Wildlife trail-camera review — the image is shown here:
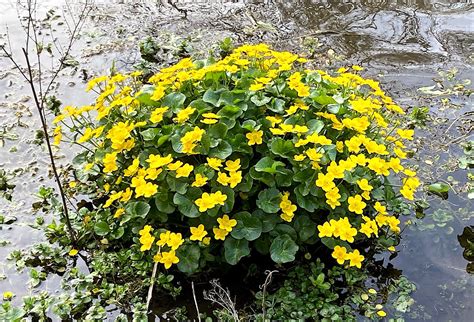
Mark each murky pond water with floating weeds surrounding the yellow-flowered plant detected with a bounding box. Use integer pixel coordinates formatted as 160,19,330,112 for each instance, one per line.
0,0,474,321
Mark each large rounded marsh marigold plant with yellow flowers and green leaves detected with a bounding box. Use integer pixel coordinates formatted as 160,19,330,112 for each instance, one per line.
54,44,420,273
